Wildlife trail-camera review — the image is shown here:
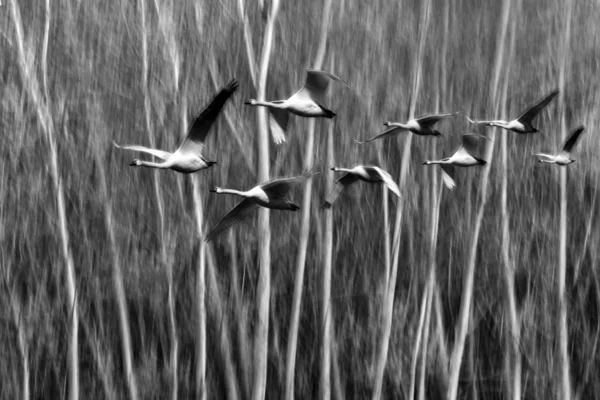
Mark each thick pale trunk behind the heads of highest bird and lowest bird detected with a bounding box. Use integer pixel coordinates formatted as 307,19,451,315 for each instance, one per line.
252,0,279,400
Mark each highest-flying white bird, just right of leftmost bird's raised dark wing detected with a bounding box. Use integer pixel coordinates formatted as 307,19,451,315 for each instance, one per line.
245,69,347,144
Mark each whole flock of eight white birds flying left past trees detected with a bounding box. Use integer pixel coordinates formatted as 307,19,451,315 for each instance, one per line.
113,70,584,241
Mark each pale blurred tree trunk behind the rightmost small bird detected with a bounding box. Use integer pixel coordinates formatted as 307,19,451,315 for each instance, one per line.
558,0,573,400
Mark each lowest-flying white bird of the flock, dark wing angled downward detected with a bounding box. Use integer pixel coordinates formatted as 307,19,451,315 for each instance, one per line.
204,173,314,242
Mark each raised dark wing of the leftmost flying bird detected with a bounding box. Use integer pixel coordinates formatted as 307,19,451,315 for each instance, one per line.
179,79,238,154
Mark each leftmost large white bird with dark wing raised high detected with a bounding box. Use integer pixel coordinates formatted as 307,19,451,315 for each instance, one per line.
113,79,238,174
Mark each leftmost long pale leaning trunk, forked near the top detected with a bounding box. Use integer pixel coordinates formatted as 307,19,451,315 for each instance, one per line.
11,0,79,400
